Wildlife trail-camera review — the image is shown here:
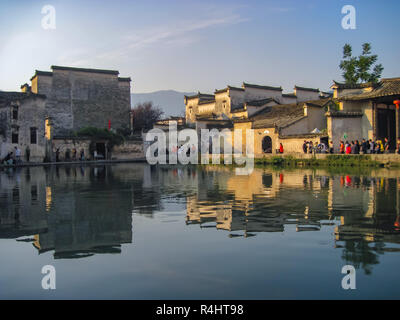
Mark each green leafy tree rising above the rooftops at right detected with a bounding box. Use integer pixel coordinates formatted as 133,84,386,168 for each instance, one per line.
339,43,383,84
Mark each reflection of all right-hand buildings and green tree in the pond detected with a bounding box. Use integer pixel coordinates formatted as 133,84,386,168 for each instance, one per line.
186,167,400,273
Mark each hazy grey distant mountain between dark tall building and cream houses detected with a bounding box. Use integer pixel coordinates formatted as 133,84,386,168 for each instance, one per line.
131,90,195,117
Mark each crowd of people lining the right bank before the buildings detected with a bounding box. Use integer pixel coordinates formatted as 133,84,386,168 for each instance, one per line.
303,138,400,154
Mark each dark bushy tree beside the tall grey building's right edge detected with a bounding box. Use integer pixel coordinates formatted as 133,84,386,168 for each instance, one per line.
132,101,164,132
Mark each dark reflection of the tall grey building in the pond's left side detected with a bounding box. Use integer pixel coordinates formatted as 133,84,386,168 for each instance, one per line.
0,166,134,258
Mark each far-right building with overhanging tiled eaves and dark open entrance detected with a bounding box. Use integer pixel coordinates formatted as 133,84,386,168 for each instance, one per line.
327,78,400,150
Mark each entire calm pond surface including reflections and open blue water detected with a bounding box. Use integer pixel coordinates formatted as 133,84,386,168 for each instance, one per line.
0,164,400,299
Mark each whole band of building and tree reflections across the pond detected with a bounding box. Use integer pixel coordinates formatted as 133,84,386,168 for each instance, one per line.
0,164,400,274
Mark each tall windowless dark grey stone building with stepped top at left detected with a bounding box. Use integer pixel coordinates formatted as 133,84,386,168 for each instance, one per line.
26,66,131,136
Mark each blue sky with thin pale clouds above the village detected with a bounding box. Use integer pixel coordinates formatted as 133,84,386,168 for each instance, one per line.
0,0,400,93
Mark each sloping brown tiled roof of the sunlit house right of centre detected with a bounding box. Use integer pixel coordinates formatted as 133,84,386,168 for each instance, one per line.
250,99,331,128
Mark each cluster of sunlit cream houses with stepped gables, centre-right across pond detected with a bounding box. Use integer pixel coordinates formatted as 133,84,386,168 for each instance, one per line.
185,83,333,157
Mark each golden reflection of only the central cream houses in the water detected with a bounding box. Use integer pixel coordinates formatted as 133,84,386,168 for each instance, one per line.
187,169,329,236
